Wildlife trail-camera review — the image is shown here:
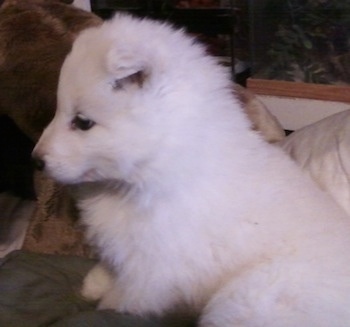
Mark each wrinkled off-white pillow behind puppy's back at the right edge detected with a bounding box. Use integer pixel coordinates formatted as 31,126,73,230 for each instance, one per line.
280,110,350,214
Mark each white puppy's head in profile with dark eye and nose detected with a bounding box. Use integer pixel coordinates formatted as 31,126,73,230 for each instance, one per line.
33,16,234,187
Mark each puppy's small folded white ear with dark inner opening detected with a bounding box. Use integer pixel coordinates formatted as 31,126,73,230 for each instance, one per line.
107,49,149,89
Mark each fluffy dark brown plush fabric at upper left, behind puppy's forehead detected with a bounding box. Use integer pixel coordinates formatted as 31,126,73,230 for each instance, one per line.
0,0,101,140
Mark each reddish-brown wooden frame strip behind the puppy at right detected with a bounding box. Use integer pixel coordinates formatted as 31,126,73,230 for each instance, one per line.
247,78,350,102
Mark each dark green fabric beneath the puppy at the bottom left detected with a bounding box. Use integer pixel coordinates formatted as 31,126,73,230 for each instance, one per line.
0,251,195,327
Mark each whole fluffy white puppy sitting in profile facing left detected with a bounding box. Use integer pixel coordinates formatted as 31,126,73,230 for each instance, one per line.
34,15,350,327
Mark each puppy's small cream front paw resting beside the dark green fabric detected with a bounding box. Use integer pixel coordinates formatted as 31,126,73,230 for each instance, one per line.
81,264,114,301
